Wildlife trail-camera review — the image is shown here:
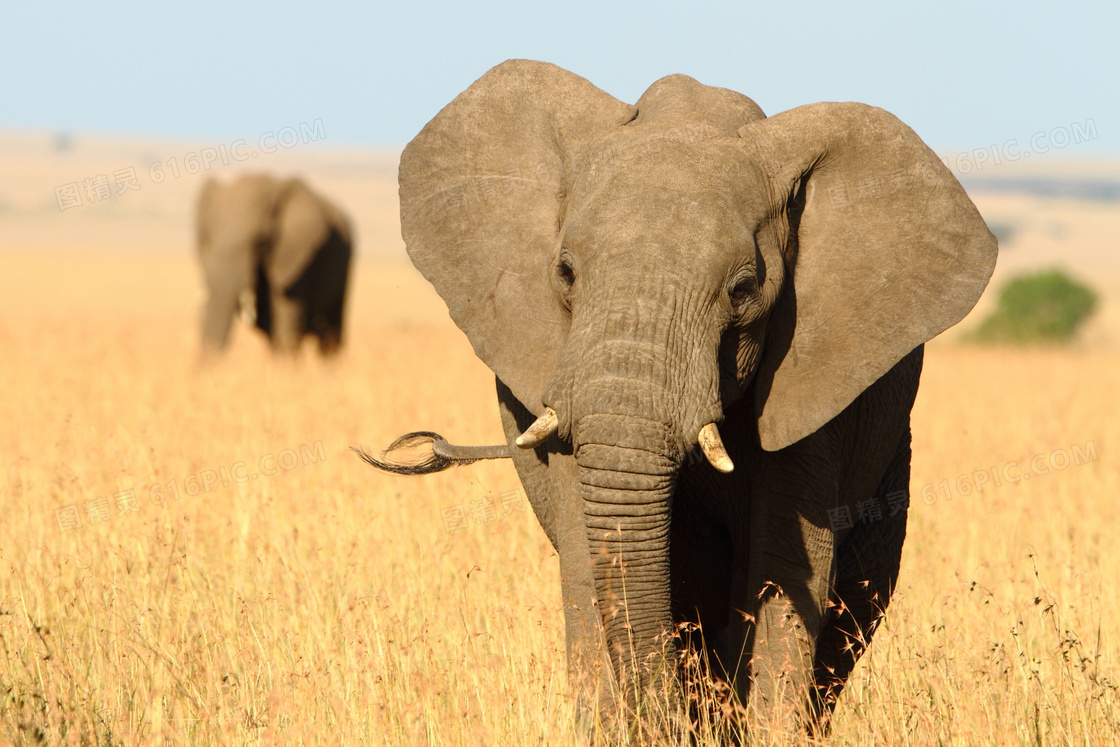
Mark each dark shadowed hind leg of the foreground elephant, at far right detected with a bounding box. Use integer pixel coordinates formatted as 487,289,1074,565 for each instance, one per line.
813,430,911,730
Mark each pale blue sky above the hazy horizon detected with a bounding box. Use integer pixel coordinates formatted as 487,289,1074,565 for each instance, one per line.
0,0,1120,155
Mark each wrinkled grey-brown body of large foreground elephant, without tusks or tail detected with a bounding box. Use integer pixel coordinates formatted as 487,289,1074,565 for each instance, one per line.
400,60,996,734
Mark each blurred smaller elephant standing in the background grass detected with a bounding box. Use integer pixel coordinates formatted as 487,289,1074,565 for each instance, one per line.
197,175,351,355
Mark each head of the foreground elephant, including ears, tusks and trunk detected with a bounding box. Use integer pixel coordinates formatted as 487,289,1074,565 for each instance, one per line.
400,60,996,703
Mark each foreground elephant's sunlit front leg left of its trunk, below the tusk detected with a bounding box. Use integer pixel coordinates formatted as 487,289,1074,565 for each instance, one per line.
497,380,616,717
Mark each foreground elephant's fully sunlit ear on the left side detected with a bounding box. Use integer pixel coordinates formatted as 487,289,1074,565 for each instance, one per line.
400,60,635,413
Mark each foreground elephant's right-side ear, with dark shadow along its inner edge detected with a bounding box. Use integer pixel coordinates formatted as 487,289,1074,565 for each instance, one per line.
739,103,996,451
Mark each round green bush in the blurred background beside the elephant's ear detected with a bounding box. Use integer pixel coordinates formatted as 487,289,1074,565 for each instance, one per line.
968,270,1096,345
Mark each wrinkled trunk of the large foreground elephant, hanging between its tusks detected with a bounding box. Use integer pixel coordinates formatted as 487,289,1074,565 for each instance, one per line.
560,271,719,704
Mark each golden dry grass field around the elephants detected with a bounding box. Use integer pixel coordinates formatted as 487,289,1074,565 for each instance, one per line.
0,252,1120,745
